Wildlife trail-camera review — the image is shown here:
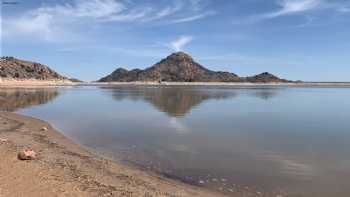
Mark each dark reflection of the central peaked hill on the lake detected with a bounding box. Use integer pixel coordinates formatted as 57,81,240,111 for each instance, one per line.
104,87,238,117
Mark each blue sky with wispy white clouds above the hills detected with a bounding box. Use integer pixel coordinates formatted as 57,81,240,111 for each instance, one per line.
1,0,350,81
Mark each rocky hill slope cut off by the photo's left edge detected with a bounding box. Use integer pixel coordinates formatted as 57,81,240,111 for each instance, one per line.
0,57,68,80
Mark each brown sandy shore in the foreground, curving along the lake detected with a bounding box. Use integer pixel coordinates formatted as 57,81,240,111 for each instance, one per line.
0,112,226,197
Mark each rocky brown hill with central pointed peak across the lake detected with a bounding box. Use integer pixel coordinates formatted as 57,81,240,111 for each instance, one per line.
98,52,287,83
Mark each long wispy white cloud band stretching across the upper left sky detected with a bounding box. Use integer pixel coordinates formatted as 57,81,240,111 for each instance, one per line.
3,0,214,41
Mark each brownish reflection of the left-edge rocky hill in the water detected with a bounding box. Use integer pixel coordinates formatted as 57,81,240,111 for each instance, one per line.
0,88,59,111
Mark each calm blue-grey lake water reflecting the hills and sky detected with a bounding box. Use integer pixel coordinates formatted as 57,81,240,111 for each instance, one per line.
0,86,350,197
